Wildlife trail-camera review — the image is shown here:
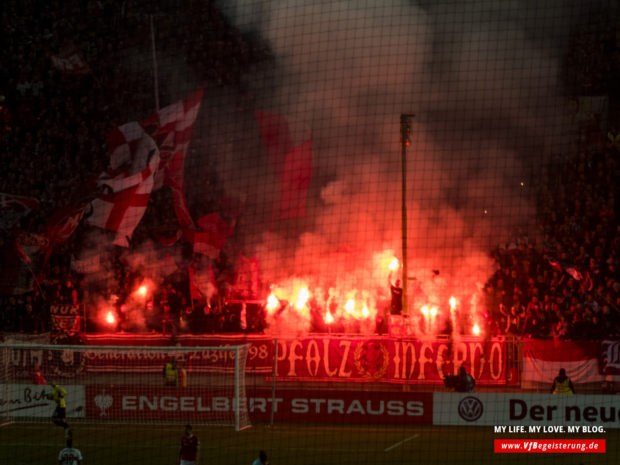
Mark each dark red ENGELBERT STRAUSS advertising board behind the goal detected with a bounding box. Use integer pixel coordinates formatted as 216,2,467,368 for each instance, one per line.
86,385,433,425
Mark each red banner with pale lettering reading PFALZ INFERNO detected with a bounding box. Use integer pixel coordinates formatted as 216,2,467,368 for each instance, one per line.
277,337,506,384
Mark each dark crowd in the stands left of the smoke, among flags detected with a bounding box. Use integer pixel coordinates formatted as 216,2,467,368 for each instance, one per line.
0,0,266,333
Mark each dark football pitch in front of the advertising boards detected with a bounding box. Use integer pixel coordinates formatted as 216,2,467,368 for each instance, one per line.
0,423,620,465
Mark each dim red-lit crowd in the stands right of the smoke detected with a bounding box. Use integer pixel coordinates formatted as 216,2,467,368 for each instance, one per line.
485,148,620,340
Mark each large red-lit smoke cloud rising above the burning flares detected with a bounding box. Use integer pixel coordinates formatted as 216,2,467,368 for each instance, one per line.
208,0,592,334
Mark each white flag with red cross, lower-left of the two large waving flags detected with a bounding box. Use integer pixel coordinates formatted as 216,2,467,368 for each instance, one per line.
87,134,160,247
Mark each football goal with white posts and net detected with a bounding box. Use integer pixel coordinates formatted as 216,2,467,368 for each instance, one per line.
0,344,250,431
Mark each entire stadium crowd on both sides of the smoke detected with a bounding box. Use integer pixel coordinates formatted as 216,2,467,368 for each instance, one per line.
0,0,620,339
